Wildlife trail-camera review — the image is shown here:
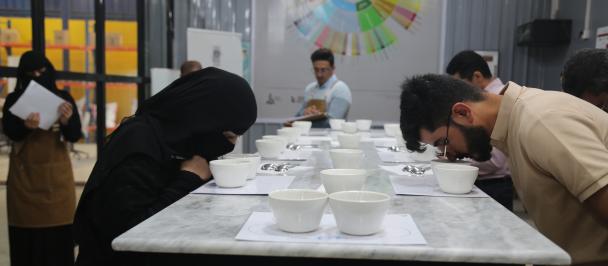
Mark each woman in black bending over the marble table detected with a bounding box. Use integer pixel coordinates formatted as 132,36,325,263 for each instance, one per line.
74,67,257,265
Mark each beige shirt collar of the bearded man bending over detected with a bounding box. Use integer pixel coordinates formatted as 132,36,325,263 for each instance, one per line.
491,81,524,156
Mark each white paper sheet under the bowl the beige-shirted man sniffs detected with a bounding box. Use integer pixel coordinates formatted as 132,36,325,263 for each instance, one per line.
390,173,488,198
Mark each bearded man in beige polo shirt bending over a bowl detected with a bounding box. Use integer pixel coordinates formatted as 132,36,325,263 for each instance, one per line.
400,74,608,265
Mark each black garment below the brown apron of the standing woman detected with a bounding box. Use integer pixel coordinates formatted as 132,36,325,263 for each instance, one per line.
8,225,74,266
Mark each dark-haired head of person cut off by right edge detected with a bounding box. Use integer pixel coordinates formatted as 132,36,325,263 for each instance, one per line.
562,49,608,112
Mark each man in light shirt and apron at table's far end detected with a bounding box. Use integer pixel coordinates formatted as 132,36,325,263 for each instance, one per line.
296,48,352,128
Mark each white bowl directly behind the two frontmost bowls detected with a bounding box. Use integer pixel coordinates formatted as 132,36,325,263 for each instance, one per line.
321,169,367,194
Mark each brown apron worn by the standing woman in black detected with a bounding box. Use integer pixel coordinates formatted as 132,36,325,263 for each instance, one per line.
6,125,76,228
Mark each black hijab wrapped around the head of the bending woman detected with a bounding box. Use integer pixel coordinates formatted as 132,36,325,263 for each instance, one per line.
136,67,257,160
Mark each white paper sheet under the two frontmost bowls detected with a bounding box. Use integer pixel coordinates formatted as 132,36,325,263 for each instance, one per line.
235,212,427,245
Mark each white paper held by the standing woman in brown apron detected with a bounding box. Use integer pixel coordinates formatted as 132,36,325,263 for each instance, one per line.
9,80,65,130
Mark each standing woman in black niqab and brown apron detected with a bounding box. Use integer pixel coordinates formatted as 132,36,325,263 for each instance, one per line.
2,51,82,266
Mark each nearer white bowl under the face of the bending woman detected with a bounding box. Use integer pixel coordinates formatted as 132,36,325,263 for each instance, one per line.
209,159,251,188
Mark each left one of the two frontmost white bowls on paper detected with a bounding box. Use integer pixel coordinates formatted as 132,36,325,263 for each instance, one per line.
268,189,328,233
